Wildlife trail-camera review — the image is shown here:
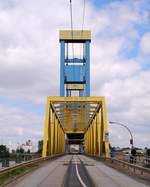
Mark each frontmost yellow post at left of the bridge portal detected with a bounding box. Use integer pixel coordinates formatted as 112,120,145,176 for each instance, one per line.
42,98,50,159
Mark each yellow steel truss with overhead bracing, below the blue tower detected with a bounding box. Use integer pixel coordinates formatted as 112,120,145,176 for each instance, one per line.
42,97,109,158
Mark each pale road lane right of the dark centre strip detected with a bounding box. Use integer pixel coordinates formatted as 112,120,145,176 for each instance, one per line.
80,155,148,187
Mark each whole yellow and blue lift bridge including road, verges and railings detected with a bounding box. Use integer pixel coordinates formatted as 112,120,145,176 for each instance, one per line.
0,30,150,187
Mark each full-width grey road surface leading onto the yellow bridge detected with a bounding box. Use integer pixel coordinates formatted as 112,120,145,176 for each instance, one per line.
7,155,148,187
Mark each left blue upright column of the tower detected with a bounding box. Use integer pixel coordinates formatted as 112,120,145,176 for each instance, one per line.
60,41,65,96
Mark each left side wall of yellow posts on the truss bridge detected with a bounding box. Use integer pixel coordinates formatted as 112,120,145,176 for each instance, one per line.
42,97,65,159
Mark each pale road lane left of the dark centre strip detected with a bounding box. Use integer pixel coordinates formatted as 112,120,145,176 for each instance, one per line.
7,155,71,187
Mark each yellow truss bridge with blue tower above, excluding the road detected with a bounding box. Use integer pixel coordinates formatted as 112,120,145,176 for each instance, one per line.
42,30,109,158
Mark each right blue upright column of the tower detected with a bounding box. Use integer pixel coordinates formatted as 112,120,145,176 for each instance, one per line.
85,41,90,96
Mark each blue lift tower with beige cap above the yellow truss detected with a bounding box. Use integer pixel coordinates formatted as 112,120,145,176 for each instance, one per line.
59,30,91,97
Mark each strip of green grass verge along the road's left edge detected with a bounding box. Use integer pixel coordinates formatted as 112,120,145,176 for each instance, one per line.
0,163,39,186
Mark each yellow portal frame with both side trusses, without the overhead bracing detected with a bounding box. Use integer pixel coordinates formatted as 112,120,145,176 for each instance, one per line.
42,97,110,158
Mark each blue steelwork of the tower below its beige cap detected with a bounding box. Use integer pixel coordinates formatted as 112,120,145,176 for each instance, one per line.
60,40,90,97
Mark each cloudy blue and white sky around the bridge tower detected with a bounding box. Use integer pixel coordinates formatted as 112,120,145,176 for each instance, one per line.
0,0,150,147
